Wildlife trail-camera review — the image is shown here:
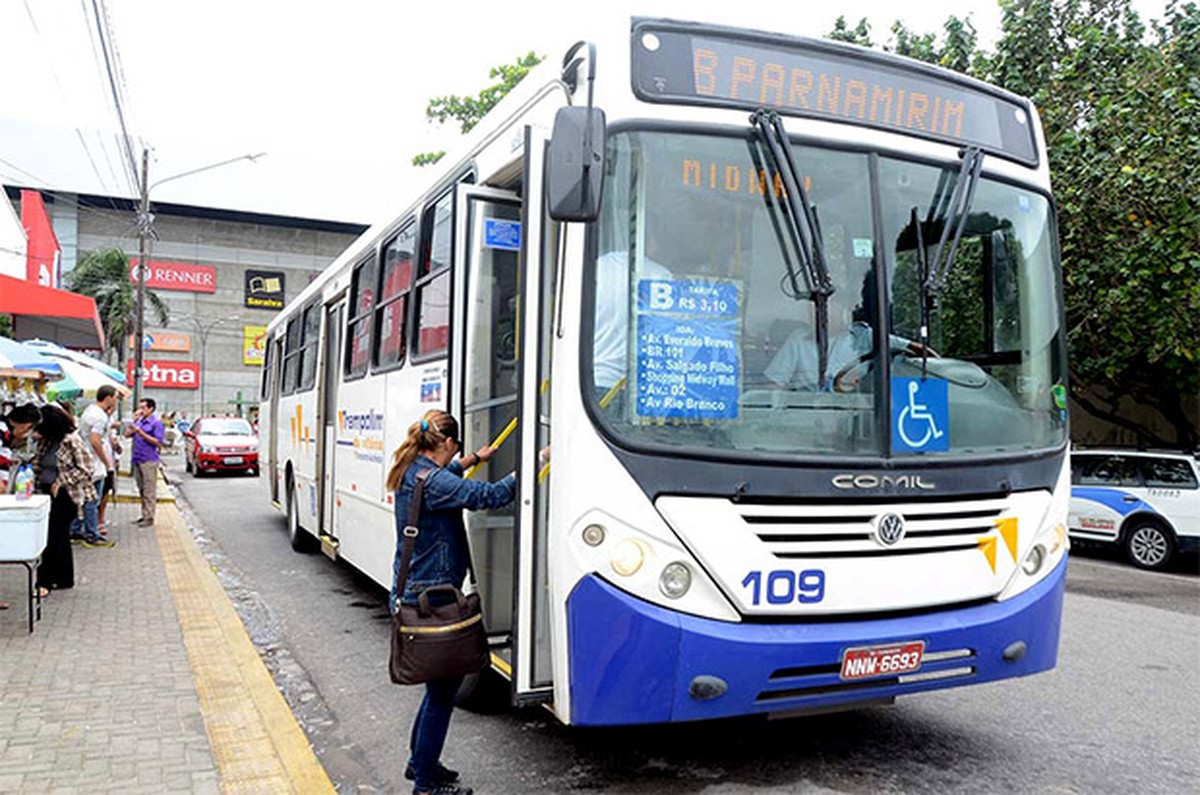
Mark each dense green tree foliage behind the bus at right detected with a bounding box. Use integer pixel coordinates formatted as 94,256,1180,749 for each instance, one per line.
825,0,1200,447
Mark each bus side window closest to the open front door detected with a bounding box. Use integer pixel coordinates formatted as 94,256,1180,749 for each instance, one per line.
413,193,454,359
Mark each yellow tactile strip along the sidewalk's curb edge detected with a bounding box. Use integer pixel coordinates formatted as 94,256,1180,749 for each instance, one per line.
155,506,335,795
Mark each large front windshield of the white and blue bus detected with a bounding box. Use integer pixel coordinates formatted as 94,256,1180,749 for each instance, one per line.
586,131,1066,458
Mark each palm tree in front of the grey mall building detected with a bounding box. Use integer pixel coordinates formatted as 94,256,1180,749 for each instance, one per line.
66,249,170,367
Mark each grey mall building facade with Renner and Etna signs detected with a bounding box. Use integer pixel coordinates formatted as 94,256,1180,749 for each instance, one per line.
10,190,366,418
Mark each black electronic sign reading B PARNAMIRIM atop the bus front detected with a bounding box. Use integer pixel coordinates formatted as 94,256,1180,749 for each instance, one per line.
632,23,1038,166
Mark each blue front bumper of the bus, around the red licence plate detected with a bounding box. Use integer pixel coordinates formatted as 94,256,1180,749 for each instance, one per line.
566,557,1067,725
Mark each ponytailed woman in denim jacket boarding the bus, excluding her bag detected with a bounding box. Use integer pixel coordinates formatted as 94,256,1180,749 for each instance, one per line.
388,410,517,795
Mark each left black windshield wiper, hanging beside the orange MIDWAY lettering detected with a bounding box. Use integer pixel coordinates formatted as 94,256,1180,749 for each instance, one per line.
750,108,834,384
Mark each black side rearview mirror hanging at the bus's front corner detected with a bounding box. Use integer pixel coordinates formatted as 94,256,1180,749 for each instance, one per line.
546,107,605,221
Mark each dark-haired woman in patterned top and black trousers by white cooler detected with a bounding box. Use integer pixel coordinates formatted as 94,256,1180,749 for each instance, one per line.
34,404,96,597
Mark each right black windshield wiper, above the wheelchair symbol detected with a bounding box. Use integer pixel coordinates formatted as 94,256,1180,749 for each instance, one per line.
912,147,983,378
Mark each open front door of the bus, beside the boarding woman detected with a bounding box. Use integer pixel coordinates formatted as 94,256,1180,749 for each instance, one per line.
451,133,552,704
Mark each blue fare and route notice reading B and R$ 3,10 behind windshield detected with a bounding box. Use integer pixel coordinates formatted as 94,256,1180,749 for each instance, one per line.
634,279,742,420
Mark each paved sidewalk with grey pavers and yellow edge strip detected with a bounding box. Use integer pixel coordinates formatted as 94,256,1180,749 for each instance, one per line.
0,477,334,793
